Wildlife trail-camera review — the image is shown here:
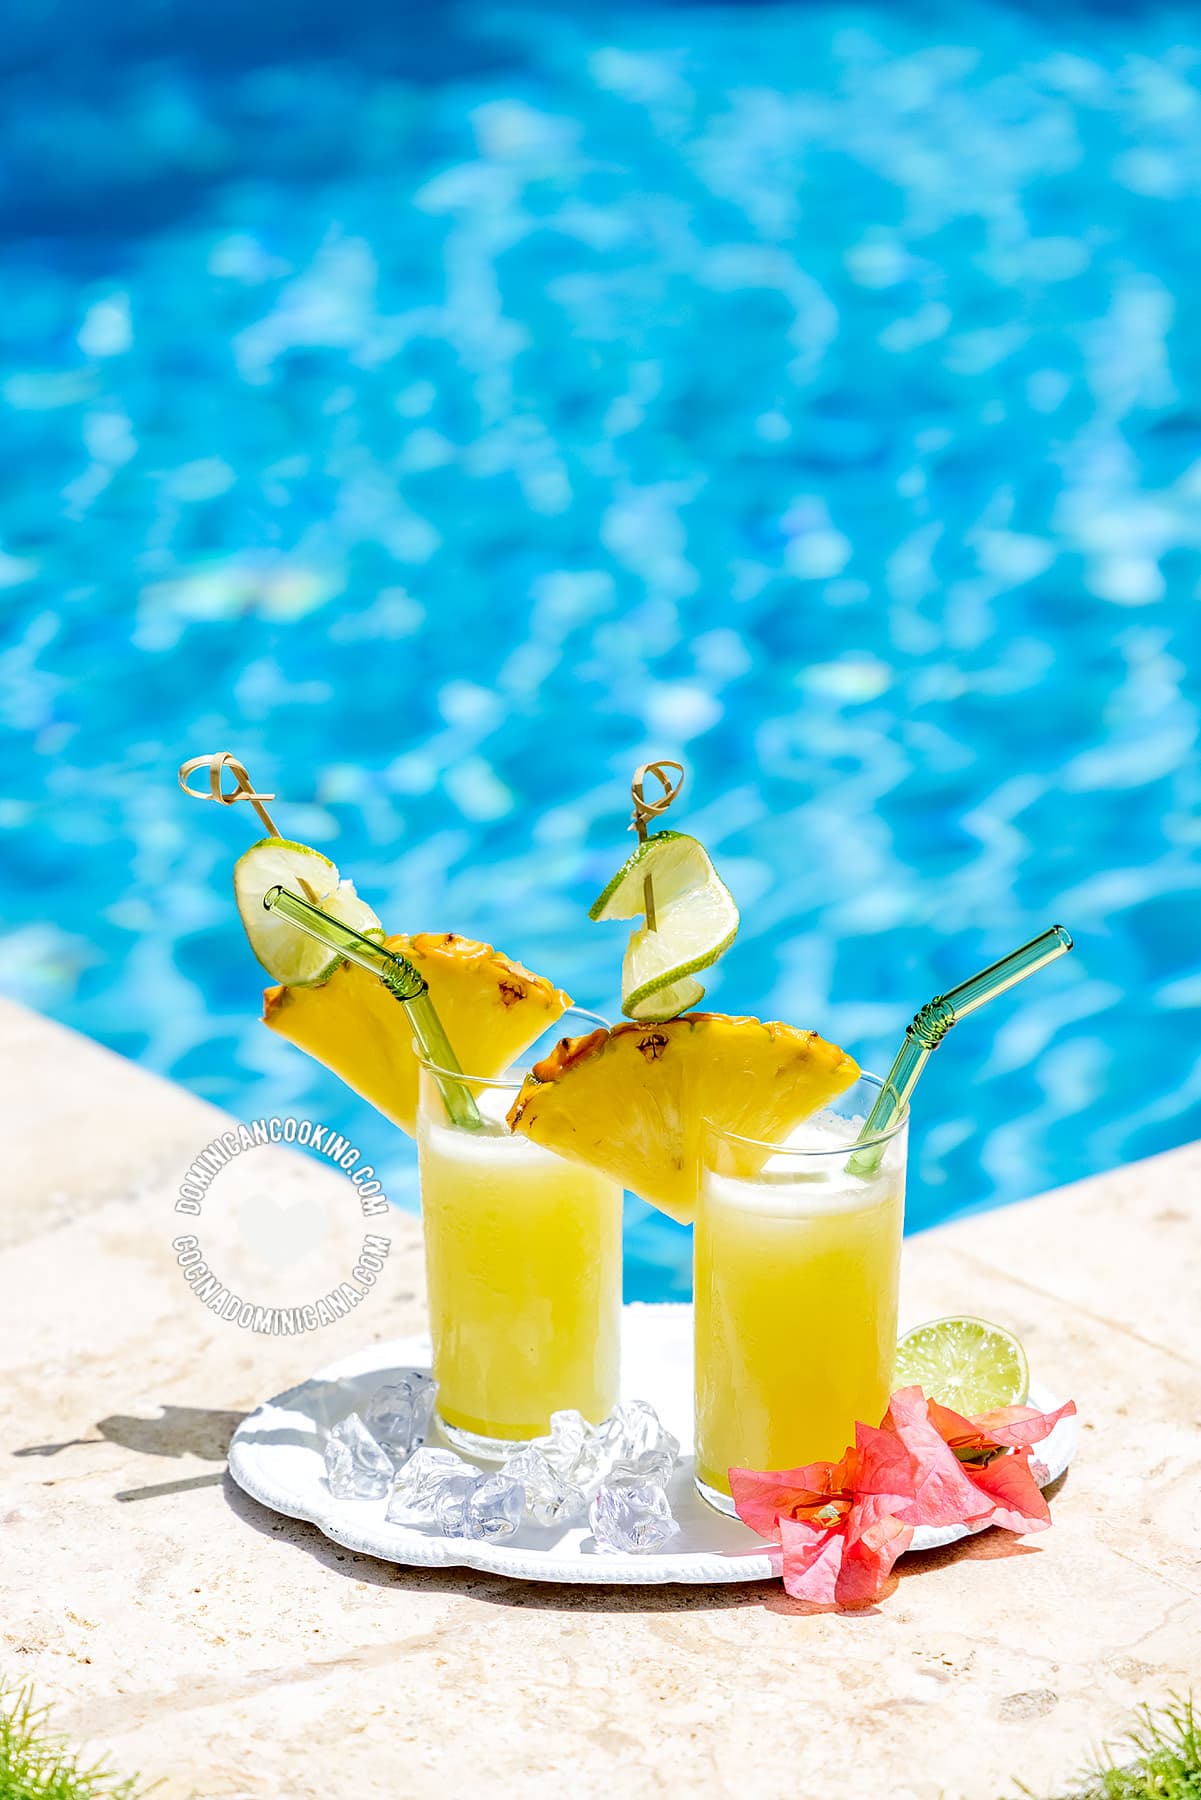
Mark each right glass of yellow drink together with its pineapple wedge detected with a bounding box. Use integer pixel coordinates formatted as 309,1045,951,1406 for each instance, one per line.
508,1012,878,1483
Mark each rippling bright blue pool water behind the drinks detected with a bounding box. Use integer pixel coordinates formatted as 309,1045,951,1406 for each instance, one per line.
0,0,1201,1294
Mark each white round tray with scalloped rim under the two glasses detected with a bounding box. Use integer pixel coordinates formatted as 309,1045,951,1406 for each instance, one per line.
229,1305,1077,1586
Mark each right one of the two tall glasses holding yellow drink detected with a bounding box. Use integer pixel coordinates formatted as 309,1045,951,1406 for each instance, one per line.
693,1075,909,1512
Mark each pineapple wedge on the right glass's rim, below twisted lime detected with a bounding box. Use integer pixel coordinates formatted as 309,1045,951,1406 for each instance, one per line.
508,1013,859,1224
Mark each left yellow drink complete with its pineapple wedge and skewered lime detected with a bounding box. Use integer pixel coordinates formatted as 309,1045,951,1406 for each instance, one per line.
226,828,621,1456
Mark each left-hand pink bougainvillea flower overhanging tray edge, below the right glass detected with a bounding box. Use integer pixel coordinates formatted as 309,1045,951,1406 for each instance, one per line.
729,1424,917,1606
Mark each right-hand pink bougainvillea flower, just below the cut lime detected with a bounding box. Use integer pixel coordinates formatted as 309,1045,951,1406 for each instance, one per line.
884,1388,1075,1532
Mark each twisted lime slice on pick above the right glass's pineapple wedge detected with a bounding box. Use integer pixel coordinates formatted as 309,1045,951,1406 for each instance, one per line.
589,832,738,1019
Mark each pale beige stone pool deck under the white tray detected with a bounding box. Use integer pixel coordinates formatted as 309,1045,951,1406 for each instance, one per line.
0,1003,1201,1800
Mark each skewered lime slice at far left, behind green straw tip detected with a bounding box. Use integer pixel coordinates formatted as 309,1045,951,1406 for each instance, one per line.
234,837,384,988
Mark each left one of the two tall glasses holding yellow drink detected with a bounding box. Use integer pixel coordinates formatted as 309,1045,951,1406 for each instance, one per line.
418,1008,621,1458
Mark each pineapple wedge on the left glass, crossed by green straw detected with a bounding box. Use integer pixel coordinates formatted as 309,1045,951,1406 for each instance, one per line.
263,932,571,1136
